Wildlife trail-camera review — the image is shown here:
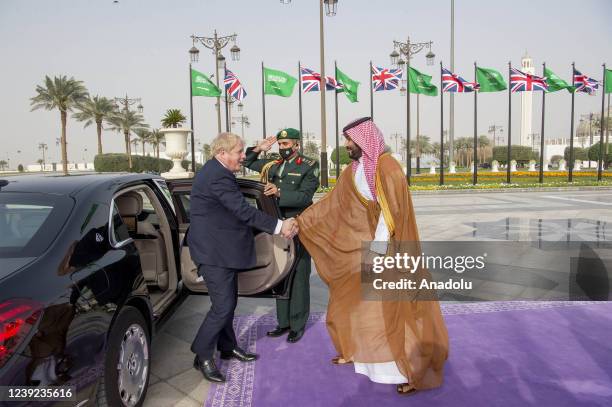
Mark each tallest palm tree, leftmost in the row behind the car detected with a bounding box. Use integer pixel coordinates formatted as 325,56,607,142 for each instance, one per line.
30,75,88,175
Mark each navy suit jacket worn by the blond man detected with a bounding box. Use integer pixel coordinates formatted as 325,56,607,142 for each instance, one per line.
187,158,278,269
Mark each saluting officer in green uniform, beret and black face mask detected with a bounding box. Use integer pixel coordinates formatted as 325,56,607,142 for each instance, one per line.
243,128,319,343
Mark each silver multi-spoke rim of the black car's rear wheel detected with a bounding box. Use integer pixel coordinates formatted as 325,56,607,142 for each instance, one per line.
117,324,149,406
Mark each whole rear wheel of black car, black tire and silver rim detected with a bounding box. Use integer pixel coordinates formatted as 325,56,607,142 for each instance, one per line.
96,306,151,407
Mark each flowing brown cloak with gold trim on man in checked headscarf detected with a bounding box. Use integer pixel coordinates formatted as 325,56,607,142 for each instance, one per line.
298,154,448,389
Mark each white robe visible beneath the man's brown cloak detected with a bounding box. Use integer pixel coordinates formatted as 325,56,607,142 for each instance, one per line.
354,159,408,384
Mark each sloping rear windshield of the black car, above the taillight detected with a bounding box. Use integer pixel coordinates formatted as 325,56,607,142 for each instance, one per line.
0,192,74,258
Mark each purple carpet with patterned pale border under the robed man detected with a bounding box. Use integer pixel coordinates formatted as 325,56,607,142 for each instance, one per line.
206,302,612,407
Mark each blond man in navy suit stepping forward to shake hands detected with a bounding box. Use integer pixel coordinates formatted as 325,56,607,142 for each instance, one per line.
187,133,297,382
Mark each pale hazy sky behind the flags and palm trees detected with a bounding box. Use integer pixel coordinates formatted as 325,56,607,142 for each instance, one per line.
0,0,612,164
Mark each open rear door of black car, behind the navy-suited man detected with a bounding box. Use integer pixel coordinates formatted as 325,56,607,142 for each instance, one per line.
168,178,297,298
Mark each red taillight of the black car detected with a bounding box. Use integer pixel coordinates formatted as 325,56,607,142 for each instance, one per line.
0,299,42,367
